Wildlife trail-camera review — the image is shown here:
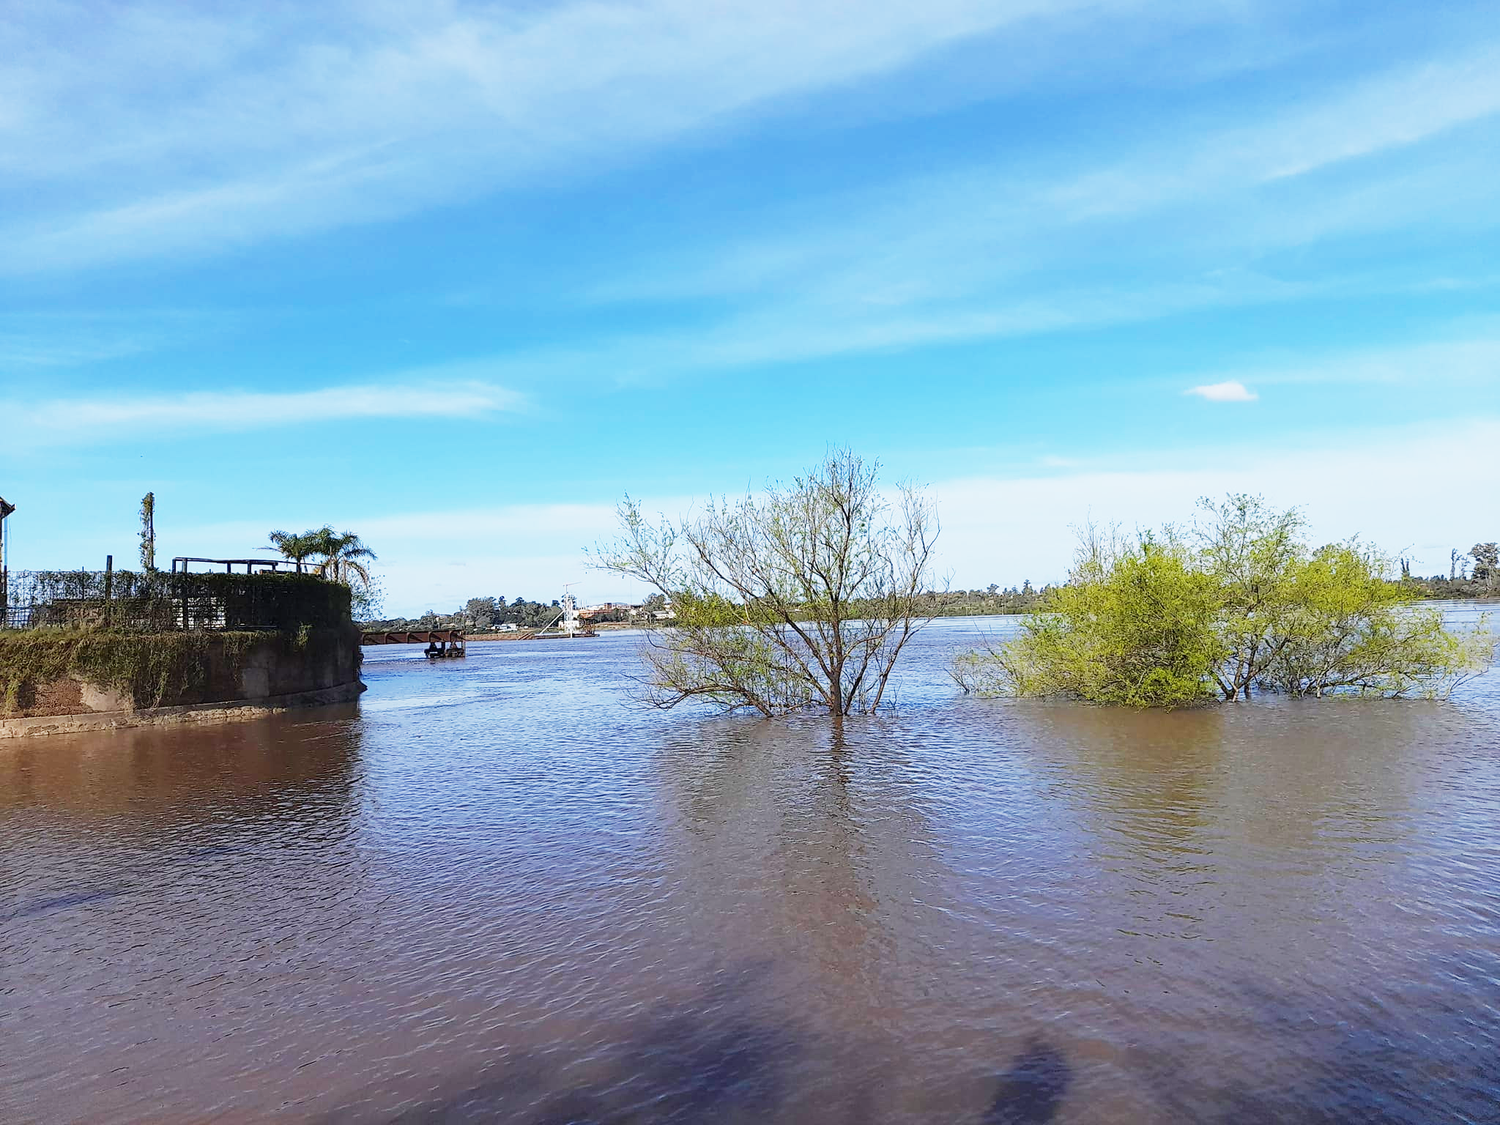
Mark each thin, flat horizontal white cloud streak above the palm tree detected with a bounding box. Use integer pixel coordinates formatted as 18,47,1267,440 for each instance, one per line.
0,383,524,449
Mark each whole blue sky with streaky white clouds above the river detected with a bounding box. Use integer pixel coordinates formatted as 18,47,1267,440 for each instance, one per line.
0,0,1500,614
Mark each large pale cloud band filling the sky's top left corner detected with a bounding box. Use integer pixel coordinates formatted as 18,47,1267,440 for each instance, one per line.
0,0,1136,273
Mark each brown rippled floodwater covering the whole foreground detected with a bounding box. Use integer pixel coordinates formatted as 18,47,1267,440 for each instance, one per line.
0,621,1500,1125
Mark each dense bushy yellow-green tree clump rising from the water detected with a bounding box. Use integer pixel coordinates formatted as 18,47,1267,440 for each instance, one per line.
954,495,1494,707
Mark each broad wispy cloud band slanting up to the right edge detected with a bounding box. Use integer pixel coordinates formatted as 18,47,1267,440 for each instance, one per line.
540,33,1500,386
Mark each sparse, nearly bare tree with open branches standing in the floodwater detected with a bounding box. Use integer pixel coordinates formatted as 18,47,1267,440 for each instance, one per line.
599,450,938,716
